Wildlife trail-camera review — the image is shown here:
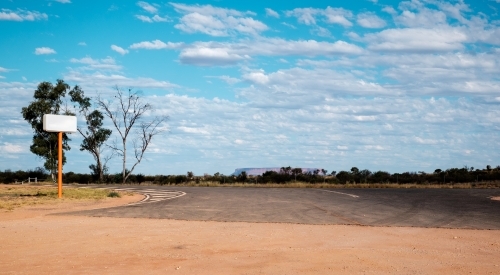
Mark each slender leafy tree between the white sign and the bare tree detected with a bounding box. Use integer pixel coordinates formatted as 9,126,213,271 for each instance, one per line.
69,86,112,182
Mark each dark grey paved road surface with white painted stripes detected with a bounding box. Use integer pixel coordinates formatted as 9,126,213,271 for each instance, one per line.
62,186,500,229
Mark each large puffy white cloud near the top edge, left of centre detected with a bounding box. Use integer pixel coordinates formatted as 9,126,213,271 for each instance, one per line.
170,3,268,36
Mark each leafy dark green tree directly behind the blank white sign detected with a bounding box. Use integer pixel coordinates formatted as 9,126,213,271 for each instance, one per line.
21,79,71,182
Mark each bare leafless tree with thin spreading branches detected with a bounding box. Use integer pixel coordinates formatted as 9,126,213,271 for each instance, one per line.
97,87,168,183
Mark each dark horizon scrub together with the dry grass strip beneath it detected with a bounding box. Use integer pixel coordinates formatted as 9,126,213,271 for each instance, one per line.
0,165,500,188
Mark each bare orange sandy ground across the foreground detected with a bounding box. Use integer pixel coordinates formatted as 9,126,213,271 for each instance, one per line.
0,195,500,274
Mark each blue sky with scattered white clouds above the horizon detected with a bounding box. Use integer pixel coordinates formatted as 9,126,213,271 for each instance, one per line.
0,0,500,175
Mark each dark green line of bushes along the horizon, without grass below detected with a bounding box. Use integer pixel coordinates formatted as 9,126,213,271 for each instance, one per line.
0,165,500,185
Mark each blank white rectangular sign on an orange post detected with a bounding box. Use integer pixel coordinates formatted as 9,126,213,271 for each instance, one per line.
43,114,76,198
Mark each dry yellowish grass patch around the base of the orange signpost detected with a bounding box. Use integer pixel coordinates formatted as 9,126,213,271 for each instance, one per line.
0,185,127,210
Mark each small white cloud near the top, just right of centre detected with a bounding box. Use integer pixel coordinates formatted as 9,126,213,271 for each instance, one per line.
286,7,352,27
